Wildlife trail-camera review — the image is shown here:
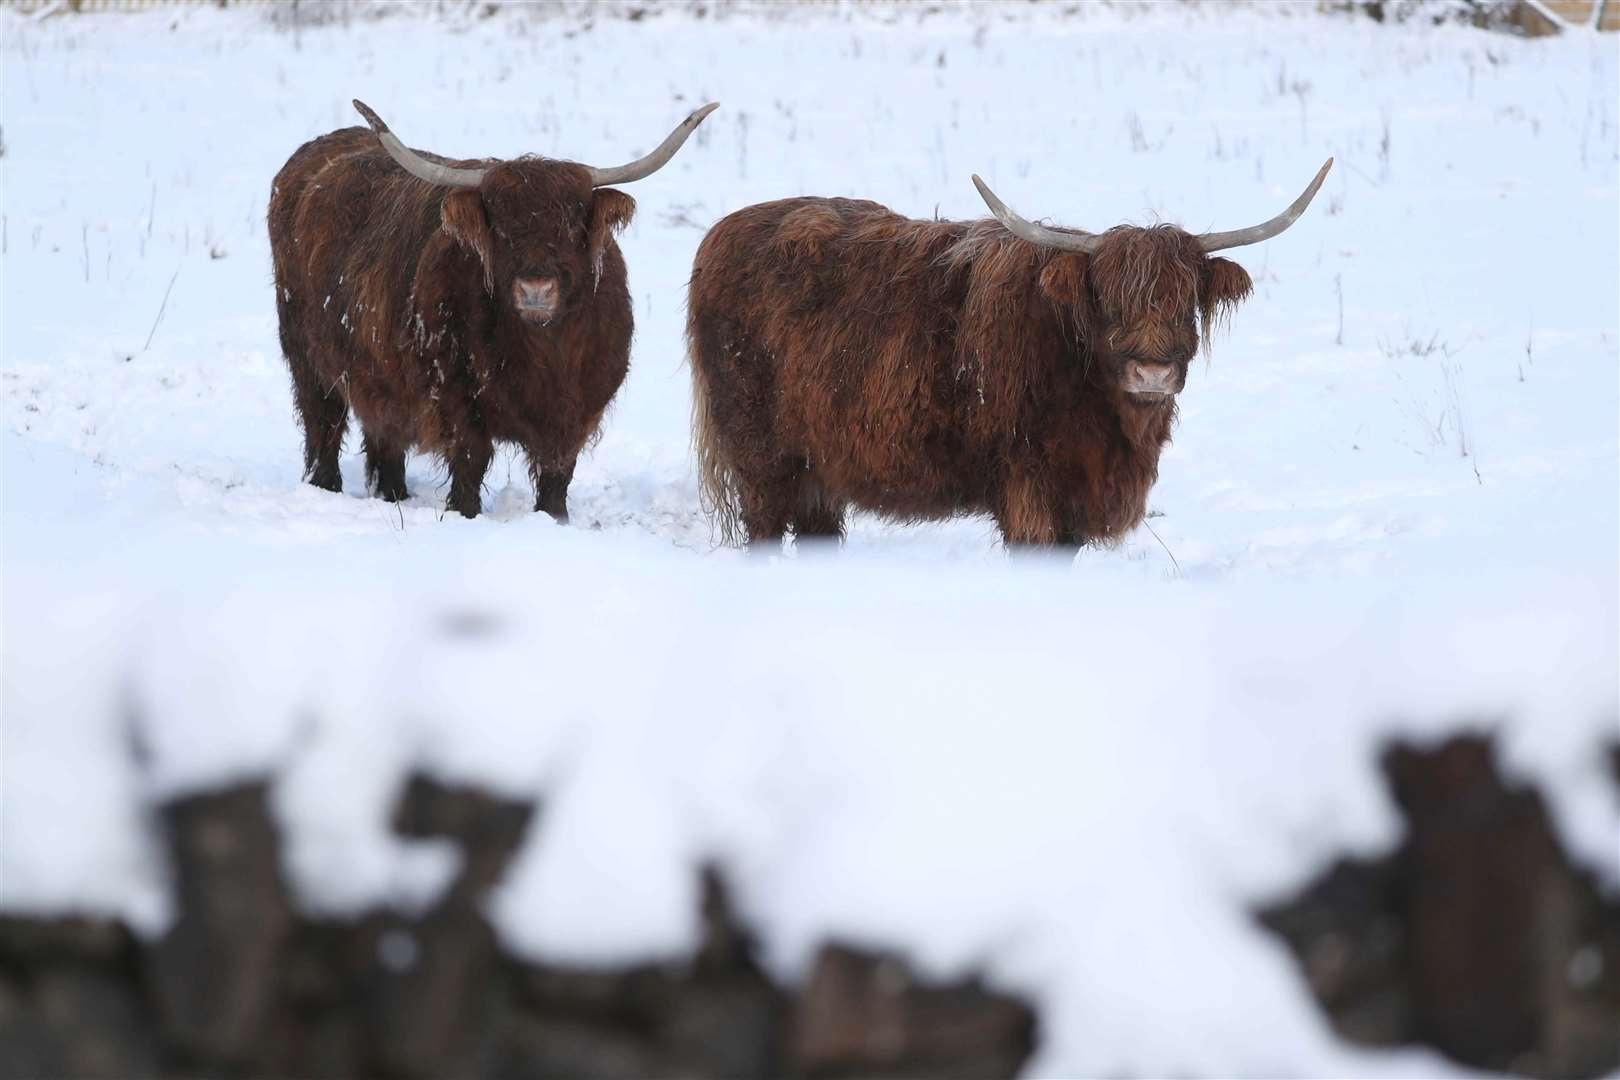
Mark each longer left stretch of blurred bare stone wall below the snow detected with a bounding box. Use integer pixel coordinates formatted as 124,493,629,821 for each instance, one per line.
0,777,1035,1080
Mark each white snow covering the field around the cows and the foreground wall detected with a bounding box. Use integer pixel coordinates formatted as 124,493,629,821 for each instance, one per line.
0,5,1620,1075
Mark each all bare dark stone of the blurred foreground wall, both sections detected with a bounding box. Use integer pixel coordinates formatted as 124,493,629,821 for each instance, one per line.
0,735,1620,1080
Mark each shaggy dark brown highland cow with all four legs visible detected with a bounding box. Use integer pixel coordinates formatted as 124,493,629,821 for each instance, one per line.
269,102,716,521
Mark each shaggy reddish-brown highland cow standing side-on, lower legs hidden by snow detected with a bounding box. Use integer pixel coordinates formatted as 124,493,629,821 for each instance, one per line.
687,159,1333,546
